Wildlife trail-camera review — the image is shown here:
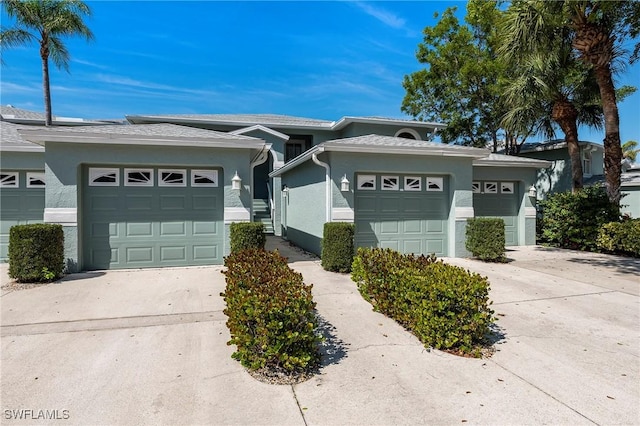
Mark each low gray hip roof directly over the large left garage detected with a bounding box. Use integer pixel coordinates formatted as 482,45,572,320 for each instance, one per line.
19,124,264,148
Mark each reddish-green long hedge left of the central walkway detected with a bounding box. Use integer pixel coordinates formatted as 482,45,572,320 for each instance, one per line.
221,249,320,373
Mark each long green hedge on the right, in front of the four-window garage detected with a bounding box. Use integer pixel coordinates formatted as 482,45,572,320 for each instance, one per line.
351,248,495,356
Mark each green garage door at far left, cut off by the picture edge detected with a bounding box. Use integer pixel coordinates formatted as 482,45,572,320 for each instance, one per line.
0,170,44,261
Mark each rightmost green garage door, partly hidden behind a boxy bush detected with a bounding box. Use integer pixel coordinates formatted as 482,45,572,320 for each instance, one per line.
473,181,520,246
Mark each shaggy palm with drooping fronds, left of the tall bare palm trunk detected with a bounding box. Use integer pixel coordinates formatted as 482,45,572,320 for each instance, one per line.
499,2,602,191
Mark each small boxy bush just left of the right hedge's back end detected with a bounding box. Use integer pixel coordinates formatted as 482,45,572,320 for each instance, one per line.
322,222,355,272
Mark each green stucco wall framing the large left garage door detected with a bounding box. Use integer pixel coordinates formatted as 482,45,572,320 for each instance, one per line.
45,142,251,272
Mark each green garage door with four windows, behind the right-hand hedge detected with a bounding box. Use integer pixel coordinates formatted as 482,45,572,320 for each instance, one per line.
355,174,450,256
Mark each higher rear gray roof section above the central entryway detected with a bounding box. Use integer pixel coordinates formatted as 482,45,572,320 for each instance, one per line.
127,114,333,128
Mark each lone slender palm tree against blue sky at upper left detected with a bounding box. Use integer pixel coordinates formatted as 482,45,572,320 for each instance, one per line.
0,0,93,126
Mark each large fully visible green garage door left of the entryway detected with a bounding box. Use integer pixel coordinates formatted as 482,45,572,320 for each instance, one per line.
82,166,224,269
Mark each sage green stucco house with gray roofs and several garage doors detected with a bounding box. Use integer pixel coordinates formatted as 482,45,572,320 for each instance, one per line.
2,110,550,271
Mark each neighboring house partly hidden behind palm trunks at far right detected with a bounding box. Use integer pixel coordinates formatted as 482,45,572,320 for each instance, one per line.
519,140,640,218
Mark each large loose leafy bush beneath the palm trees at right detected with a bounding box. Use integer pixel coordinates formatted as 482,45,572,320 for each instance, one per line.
540,186,620,251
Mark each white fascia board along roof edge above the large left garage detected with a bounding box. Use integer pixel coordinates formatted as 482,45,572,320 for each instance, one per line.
18,130,265,149
